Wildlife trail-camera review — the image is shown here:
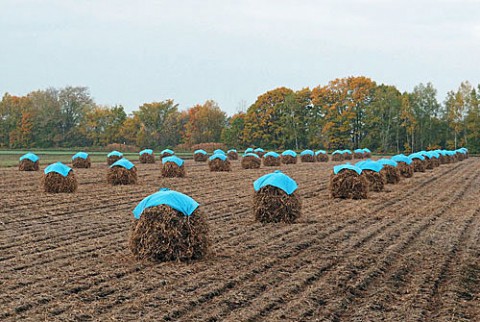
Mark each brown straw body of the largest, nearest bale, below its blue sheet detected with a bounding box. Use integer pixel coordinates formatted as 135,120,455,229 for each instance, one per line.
128,205,210,262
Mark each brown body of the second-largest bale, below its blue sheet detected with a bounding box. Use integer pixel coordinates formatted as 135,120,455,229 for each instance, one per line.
253,186,302,224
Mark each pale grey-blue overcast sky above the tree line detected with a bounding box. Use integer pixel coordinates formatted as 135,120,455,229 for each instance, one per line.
0,0,480,115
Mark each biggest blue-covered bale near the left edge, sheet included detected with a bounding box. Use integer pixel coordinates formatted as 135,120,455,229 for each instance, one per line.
42,162,78,193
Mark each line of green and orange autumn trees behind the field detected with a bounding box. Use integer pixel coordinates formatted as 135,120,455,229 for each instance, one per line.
0,76,480,152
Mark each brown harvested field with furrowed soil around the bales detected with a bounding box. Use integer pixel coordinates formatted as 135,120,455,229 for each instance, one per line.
0,158,480,321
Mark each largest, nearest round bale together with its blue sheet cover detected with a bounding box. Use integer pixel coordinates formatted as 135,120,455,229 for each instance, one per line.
129,190,210,262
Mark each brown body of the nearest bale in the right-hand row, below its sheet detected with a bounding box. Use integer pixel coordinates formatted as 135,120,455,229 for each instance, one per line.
329,169,368,199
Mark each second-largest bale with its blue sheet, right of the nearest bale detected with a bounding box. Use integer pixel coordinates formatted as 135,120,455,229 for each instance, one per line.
253,170,302,224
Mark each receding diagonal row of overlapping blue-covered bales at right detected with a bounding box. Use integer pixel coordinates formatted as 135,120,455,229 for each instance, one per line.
329,148,468,199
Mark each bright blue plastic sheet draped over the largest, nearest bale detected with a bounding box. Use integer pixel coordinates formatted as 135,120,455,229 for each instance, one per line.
133,188,199,219
